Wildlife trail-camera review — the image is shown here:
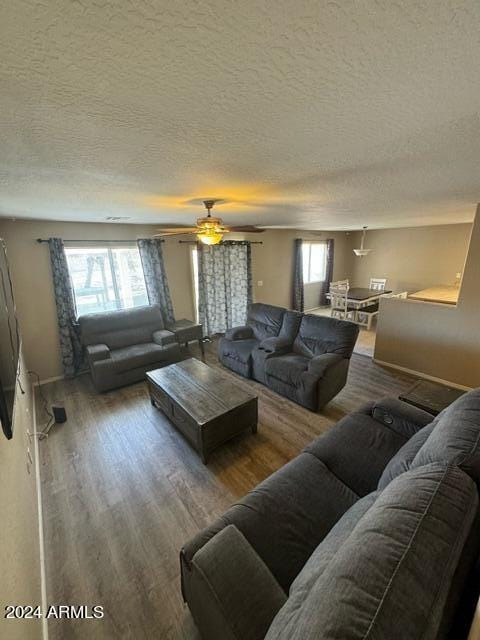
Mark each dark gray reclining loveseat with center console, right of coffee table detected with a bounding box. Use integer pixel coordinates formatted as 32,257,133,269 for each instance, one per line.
218,303,359,411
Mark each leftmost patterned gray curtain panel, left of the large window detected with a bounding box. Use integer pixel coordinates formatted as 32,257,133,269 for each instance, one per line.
48,238,85,378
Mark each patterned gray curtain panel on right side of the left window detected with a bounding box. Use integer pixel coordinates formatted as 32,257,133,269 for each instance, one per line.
137,238,175,325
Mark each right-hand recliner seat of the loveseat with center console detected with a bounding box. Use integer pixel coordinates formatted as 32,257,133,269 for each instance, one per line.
265,315,359,411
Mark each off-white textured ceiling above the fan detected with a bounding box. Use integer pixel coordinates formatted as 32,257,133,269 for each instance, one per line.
0,0,480,229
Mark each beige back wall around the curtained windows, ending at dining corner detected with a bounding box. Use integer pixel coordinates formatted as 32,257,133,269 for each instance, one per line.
0,220,350,380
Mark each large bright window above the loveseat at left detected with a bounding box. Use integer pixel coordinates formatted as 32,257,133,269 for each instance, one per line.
65,246,148,317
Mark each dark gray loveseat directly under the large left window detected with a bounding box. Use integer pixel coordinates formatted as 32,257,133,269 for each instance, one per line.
78,304,184,391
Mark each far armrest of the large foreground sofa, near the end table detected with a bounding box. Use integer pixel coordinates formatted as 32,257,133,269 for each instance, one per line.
372,397,434,438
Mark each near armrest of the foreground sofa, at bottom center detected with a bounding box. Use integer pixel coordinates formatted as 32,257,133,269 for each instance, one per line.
182,525,287,640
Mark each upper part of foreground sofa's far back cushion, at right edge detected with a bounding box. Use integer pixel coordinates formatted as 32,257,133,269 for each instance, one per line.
411,388,480,484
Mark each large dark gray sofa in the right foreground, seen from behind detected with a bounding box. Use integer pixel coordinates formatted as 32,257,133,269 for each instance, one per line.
180,389,480,640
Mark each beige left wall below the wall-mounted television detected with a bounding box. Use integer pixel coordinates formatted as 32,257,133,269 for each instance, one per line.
0,352,42,640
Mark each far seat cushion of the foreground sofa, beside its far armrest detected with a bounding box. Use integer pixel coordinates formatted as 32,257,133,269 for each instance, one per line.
305,406,406,496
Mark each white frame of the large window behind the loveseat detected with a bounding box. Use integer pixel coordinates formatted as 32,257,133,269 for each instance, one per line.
65,240,149,320
